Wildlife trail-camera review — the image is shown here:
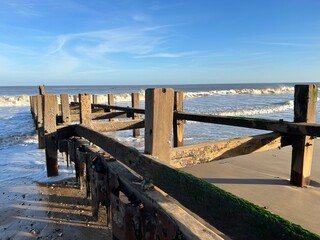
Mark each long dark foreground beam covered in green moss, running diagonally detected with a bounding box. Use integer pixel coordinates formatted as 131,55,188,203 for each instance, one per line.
67,125,317,239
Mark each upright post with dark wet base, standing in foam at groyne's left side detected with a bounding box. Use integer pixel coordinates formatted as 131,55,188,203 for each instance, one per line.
43,94,59,177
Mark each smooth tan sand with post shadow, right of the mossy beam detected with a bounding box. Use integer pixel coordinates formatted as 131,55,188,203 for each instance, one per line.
182,140,320,234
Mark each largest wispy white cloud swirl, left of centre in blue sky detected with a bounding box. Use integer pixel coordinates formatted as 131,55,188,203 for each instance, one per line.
49,26,171,58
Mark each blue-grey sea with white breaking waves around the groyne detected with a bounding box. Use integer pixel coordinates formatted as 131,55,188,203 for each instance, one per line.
0,83,320,184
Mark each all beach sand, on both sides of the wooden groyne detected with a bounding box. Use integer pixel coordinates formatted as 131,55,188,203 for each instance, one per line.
0,141,320,240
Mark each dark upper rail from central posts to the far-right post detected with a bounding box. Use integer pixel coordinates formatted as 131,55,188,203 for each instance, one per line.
174,112,320,137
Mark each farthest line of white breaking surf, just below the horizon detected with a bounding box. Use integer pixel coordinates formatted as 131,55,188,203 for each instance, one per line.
0,87,294,107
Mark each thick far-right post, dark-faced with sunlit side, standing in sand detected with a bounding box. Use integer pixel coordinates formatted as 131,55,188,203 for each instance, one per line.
290,85,318,187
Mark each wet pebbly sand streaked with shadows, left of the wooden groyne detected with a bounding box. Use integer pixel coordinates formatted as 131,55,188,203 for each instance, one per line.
0,179,112,240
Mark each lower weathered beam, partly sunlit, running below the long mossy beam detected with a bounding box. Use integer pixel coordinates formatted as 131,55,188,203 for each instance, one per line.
72,138,223,240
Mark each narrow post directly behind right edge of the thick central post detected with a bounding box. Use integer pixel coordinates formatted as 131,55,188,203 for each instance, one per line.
173,92,184,147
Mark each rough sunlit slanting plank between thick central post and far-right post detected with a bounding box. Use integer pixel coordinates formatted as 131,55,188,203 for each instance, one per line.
170,133,289,168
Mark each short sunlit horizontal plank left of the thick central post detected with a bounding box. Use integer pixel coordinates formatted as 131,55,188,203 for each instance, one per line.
91,119,144,132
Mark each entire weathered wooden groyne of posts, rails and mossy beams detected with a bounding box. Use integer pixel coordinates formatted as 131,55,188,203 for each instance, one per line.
30,85,320,239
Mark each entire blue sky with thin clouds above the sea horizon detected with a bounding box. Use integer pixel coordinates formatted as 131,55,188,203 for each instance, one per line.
0,0,320,85
